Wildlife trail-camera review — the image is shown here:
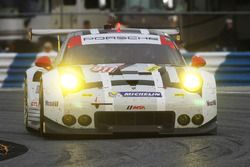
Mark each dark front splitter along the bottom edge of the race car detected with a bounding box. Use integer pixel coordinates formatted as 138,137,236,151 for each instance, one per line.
44,117,217,135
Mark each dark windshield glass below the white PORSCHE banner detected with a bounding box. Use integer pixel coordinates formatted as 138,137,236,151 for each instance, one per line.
61,44,185,66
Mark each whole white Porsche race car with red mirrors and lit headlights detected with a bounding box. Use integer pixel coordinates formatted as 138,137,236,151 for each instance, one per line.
24,28,217,135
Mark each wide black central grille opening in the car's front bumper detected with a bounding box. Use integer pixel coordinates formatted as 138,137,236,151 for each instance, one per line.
94,111,175,129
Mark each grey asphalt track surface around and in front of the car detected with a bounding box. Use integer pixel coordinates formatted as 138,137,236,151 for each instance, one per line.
0,91,250,167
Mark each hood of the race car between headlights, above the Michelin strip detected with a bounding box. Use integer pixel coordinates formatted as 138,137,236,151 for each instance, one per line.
72,63,184,88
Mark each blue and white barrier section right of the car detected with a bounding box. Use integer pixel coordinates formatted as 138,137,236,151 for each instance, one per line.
184,52,250,86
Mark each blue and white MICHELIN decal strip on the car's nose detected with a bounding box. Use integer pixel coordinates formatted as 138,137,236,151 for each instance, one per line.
109,92,162,97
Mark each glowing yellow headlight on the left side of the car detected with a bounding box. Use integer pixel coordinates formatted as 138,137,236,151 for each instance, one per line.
61,73,78,90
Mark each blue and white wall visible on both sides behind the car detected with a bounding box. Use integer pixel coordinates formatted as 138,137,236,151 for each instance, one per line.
0,52,250,88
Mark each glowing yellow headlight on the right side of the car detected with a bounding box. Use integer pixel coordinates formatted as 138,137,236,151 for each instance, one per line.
182,73,202,92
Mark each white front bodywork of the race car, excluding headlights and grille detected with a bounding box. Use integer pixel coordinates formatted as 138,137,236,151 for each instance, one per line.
43,64,217,129
